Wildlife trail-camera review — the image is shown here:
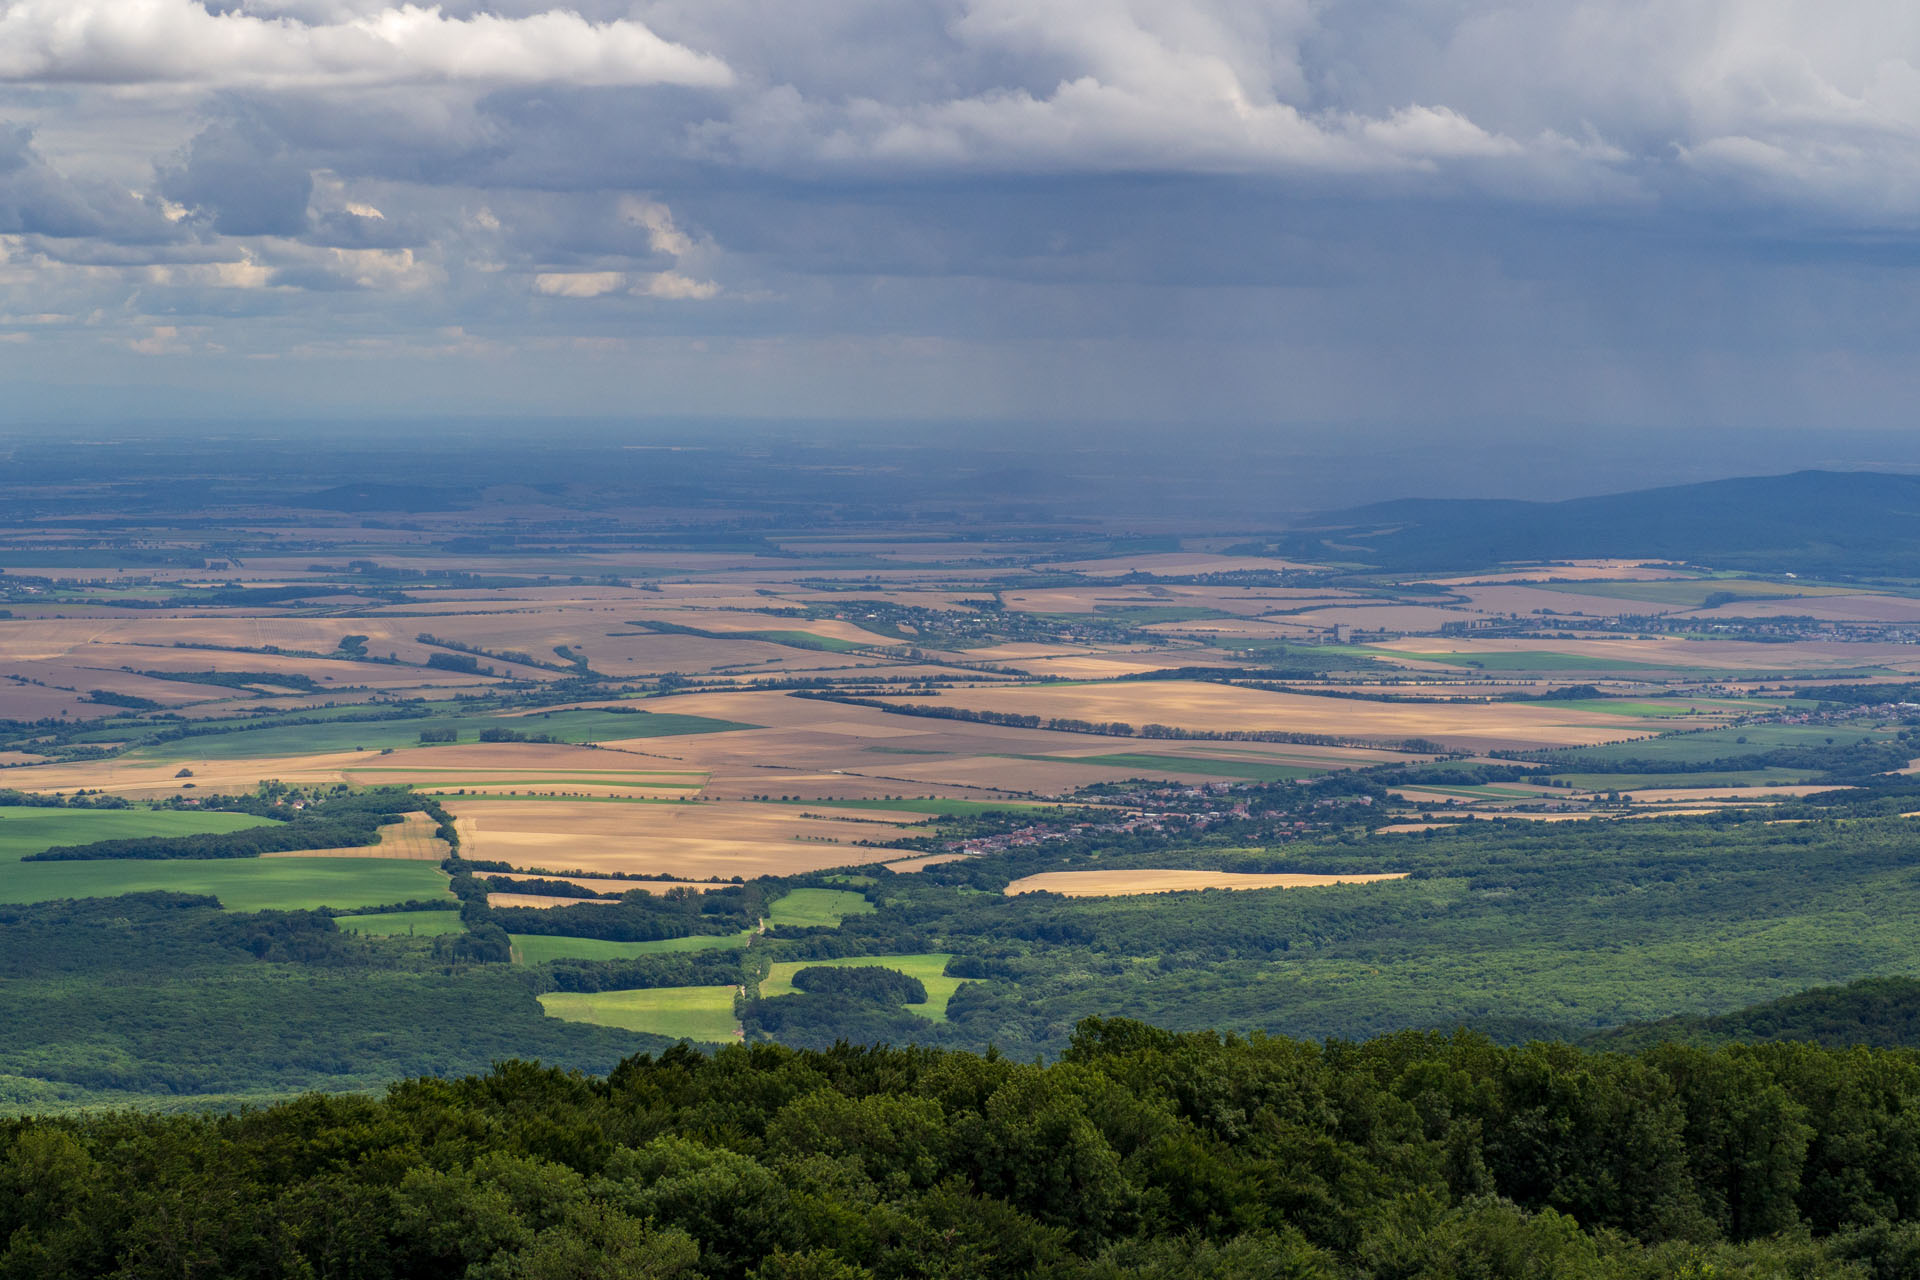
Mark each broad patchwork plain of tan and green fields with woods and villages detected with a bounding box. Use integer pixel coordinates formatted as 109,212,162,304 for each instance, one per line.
11,443,1920,1105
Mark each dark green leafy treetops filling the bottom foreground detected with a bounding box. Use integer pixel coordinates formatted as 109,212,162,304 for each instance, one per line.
11,1021,1920,1280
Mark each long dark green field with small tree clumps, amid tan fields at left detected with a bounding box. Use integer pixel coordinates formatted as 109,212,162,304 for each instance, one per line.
129,710,756,762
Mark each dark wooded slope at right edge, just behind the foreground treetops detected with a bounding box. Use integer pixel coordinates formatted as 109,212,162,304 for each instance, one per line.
1586,977,1920,1050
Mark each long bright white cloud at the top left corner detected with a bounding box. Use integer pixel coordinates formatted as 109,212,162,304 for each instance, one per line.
0,0,733,88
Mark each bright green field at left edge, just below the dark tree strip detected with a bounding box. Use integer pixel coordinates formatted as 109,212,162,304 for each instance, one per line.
0,858,453,912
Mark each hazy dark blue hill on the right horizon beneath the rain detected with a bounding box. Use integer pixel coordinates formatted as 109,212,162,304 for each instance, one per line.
1283,470,1920,574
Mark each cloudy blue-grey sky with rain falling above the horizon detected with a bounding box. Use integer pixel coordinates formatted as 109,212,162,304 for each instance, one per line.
0,0,1920,441
